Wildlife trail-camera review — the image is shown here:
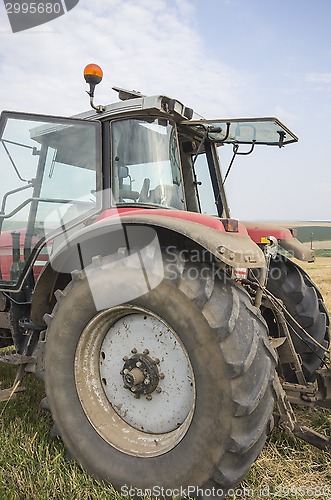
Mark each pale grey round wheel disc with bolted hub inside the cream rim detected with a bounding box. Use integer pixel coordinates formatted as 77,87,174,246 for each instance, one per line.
99,310,194,433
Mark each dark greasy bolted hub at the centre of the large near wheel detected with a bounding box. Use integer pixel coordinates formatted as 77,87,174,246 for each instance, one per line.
120,349,160,397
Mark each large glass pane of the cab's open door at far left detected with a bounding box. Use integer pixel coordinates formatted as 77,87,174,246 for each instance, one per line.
0,113,101,286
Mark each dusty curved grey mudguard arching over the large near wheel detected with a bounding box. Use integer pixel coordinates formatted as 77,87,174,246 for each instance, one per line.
31,211,266,325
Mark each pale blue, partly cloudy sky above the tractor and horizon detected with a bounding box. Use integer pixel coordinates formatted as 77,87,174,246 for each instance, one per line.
0,0,331,221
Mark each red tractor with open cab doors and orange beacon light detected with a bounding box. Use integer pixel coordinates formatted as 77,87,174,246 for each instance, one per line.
0,64,331,498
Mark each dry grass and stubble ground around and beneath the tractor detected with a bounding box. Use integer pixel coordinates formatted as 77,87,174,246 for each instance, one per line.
0,258,331,500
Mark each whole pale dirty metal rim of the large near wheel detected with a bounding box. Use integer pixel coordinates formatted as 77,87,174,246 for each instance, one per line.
75,306,195,456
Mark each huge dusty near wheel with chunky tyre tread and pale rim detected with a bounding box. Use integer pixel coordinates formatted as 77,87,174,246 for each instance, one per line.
45,256,275,498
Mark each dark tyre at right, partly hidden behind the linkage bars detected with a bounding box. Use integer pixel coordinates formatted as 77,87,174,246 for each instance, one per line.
265,255,330,383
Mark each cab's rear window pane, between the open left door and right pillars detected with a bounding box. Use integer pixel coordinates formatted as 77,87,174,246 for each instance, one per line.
111,119,185,210
